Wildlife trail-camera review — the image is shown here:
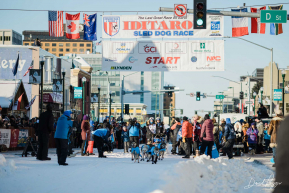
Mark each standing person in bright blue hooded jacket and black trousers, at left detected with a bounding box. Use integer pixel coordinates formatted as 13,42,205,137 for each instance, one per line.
54,110,73,166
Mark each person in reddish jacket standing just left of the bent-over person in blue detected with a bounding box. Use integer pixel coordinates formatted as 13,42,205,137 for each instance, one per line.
81,115,90,156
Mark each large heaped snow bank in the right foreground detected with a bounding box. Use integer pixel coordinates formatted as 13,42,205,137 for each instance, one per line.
153,155,272,193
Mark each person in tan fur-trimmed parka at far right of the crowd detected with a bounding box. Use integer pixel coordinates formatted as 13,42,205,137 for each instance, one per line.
268,110,283,167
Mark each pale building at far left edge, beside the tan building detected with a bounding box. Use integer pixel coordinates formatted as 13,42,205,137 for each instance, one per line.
0,29,22,45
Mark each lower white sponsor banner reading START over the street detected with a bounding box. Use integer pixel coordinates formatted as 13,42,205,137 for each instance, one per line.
102,40,224,71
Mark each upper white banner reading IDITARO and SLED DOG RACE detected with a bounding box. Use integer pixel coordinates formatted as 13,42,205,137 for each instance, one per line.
102,15,224,38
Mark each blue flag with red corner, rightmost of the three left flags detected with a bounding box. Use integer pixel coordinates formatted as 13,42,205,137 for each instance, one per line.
83,13,97,41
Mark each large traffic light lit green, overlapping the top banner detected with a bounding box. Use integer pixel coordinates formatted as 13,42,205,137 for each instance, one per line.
194,0,207,29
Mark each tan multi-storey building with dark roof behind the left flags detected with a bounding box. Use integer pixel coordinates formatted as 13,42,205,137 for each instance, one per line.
22,28,93,57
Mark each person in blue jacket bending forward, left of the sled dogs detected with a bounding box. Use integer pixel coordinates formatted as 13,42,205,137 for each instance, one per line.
91,123,112,158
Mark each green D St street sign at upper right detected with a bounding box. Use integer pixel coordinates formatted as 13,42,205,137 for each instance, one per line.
260,10,287,23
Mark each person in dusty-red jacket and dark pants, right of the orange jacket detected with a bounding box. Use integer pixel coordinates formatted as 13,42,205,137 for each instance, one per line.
200,114,214,158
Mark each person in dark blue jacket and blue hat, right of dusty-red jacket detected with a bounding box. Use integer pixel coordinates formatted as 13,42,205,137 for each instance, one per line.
222,118,235,159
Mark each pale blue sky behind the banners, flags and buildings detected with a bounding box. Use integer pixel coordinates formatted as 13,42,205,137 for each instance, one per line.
0,0,289,116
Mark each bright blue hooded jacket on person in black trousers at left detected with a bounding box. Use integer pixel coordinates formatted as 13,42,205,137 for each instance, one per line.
54,114,73,139
